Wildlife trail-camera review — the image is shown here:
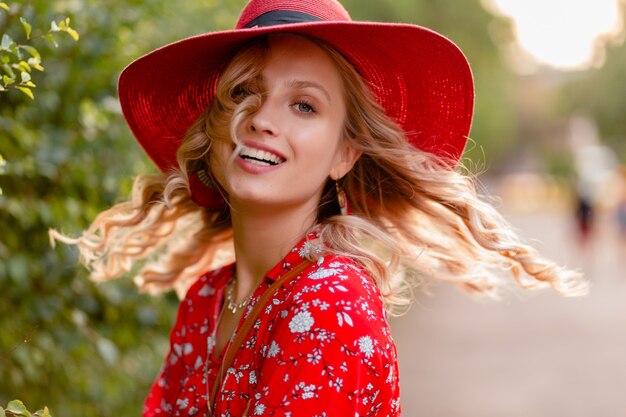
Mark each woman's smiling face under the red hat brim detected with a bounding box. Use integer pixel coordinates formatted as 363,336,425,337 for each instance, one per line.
211,35,358,213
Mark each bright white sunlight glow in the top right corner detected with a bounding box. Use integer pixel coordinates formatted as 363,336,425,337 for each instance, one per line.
484,0,623,70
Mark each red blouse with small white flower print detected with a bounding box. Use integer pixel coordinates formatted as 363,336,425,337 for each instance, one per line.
143,235,400,417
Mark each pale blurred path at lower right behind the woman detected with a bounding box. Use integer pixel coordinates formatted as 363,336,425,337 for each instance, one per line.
391,210,626,417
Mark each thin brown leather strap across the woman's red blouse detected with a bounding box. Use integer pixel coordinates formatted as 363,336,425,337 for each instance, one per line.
209,260,312,410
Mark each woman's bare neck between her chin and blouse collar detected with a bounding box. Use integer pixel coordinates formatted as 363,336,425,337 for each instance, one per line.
231,203,316,300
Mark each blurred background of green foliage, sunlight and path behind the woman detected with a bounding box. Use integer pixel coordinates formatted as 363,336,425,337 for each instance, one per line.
0,0,626,417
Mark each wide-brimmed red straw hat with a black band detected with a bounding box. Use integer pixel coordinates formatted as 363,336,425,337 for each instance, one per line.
119,0,474,177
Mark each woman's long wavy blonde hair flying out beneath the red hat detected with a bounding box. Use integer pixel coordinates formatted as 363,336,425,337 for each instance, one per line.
51,37,587,308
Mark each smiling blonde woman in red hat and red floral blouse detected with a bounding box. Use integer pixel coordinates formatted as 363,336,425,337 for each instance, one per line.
52,0,584,416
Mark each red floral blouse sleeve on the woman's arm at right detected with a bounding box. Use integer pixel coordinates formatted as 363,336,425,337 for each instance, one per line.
249,262,400,417
